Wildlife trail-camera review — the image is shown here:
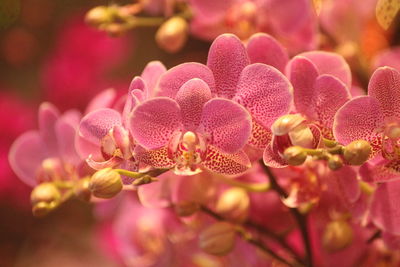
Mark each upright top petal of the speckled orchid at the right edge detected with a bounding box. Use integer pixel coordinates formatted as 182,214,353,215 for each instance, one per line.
368,67,400,118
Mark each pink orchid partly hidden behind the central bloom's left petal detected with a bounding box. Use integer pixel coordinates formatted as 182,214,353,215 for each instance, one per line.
76,61,165,175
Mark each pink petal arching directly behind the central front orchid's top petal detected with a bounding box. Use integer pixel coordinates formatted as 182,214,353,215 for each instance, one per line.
156,62,215,98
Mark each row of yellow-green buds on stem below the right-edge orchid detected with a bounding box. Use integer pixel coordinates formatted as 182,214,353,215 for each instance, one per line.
284,140,372,170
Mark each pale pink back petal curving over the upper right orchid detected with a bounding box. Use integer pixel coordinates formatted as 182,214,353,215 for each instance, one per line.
300,51,351,88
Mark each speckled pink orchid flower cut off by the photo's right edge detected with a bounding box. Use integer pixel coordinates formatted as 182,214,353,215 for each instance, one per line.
334,67,400,182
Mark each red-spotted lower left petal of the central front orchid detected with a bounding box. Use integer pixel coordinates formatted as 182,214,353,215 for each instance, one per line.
135,146,175,169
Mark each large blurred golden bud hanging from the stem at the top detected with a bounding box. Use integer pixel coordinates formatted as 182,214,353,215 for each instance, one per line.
156,17,189,53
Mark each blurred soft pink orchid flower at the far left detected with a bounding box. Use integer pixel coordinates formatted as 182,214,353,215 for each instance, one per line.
9,103,83,187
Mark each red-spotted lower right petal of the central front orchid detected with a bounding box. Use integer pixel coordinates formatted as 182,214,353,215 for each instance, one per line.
202,146,251,175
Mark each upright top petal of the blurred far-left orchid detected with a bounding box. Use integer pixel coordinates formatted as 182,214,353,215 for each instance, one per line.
39,102,60,156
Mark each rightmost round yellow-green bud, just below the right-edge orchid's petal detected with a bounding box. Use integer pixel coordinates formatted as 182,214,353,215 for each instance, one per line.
343,140,372,165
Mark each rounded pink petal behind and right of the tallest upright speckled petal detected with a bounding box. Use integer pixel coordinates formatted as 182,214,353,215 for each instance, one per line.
246,33,289,72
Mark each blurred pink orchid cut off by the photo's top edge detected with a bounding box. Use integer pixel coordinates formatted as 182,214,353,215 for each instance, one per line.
189,0,317,52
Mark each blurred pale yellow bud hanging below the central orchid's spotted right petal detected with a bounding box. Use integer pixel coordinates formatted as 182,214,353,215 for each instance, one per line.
216,187,250,222
